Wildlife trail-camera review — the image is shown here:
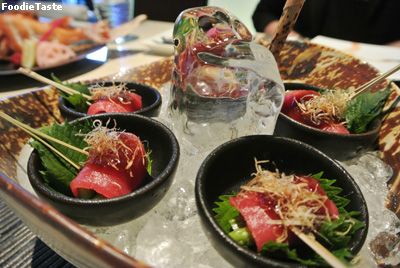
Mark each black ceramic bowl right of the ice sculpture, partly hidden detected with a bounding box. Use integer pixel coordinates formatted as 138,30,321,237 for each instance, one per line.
274,83,381,160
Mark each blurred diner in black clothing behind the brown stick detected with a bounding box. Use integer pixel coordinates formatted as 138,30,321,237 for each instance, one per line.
252,0,400,46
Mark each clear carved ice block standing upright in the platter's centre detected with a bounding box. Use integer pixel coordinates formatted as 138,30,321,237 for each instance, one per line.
169,7,284,152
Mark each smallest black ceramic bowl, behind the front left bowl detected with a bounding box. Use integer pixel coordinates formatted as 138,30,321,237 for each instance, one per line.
58,82,161,120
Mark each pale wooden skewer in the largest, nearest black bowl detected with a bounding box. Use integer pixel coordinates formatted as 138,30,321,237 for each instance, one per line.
291,227,346,268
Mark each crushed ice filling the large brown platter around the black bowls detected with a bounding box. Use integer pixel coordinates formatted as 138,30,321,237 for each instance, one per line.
85,90,400,268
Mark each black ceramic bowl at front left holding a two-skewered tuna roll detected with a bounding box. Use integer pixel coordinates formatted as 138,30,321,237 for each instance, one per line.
28,114,179,225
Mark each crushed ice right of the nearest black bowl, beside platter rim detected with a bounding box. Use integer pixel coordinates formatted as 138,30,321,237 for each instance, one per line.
342,152,400,267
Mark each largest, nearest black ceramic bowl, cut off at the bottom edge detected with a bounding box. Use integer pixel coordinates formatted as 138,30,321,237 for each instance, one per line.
195,135,368,267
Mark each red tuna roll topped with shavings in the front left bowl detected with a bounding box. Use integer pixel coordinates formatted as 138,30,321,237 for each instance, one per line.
70,127,147,198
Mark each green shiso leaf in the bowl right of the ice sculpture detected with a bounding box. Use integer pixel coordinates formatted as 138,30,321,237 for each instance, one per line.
345,88,390,133
